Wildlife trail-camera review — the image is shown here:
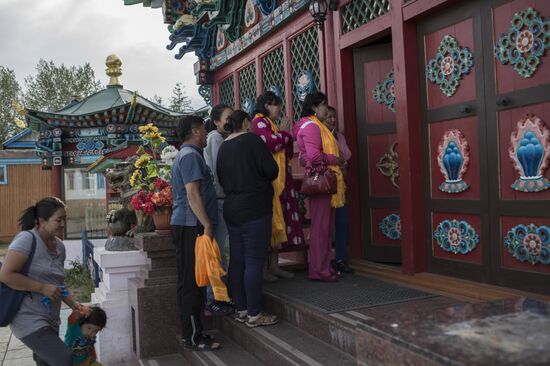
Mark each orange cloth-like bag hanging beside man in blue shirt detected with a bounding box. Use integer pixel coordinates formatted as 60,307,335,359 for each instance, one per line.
195,235,230,301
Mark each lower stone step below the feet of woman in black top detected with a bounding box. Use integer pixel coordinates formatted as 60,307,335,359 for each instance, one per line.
218,317,357,366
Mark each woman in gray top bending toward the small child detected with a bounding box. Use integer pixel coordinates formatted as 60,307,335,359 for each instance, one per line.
0,197,80,366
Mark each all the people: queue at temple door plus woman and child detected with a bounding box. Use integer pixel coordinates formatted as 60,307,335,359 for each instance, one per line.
0,92,351,360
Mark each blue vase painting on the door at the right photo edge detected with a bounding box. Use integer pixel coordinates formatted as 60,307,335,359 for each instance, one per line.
508,114,550,192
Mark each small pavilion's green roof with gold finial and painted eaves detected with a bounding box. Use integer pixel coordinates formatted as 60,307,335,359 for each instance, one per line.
24,55,183,168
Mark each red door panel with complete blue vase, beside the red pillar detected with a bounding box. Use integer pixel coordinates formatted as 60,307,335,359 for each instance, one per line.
418,3,490,280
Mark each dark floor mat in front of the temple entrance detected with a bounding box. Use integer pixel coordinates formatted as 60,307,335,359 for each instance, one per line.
263,272,438,313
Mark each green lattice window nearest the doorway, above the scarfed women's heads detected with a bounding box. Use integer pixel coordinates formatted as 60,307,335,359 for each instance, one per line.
290,27,321,121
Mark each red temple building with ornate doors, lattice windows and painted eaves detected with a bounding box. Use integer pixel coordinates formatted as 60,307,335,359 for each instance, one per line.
125,0,550,293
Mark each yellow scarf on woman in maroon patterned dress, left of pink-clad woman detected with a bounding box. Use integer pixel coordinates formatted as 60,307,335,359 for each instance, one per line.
254,113,287,247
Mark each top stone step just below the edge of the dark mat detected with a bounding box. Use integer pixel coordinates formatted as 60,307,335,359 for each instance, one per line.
262,290,358,357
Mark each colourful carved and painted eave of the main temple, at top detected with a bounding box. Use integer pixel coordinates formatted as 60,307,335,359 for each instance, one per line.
125,0,309,89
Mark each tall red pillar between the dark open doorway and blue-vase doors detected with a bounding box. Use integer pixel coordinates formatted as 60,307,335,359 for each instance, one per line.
391,0,427,274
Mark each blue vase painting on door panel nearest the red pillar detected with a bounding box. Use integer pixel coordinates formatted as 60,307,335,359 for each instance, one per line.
437,129,470,193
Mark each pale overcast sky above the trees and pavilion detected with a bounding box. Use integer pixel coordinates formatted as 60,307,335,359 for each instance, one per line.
0,0,204,107
